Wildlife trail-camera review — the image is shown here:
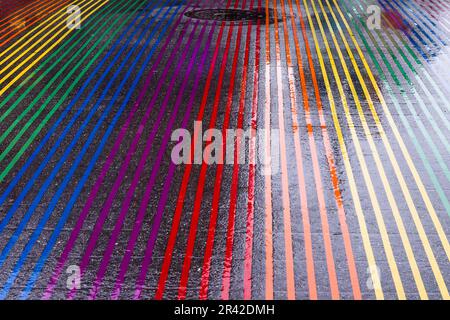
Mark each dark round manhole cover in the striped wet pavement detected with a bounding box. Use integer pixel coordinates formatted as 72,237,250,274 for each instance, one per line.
185,9,273,24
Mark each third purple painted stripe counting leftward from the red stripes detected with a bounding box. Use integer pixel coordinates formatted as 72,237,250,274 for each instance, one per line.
89,21,206,299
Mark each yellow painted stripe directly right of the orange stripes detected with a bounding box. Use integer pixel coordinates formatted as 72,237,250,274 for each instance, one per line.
296,0,384,300
